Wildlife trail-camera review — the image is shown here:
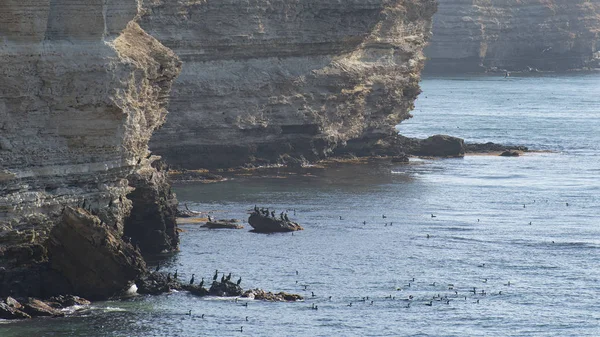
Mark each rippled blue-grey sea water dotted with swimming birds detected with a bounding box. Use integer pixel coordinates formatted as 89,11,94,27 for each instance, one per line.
0,73,600,337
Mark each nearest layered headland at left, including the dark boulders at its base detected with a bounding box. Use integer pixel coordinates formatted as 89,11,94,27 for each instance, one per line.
0,0,181,299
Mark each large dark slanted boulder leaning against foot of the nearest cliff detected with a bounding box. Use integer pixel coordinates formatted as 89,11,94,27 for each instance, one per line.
47,207,146,299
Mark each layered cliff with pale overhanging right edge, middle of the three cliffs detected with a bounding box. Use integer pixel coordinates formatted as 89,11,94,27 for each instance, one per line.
140,0,436,168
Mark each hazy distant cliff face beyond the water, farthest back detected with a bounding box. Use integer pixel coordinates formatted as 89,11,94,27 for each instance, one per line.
425,0,600,72
